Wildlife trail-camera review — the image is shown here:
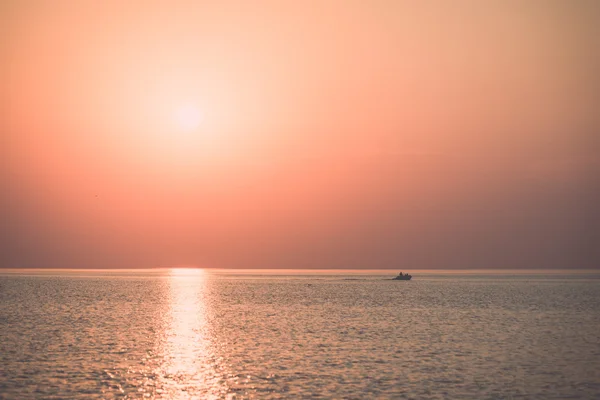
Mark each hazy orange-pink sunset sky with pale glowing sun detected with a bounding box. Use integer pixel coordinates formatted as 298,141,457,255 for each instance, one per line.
0,0,600,270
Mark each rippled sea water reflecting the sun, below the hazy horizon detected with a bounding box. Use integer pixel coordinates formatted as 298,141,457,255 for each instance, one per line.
0,270,600,399
